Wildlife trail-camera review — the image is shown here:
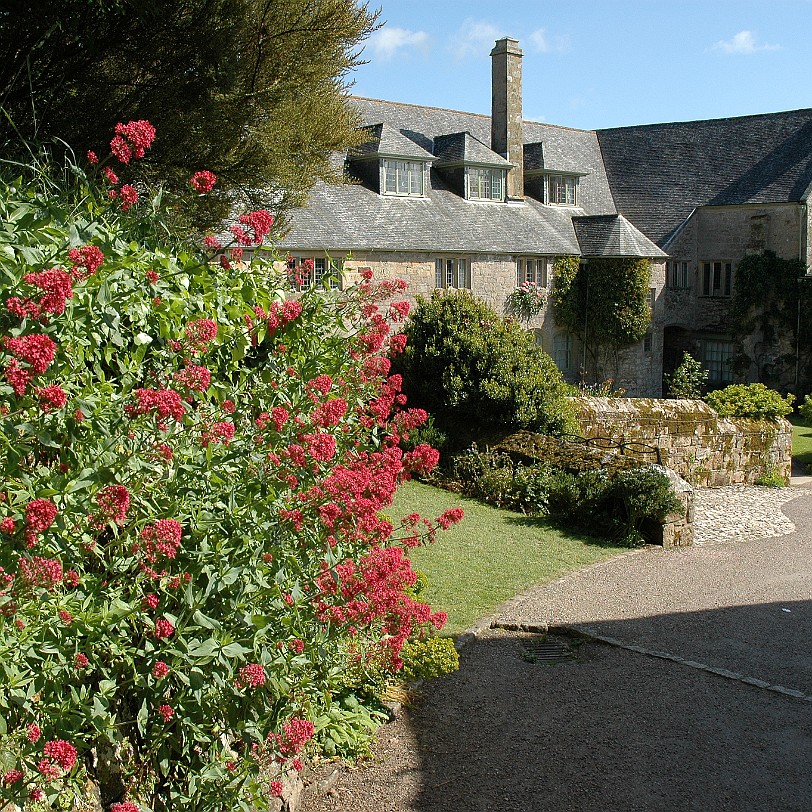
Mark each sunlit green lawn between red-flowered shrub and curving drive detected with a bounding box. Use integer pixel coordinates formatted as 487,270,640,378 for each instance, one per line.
387,482,625,635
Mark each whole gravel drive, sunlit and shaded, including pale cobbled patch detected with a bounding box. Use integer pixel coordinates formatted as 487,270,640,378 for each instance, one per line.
304,488,812,812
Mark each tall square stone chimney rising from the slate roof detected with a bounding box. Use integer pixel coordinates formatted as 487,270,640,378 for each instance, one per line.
491,37,524,200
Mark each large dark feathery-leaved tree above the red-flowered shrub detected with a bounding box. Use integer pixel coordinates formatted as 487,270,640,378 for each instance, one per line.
0,0,377,226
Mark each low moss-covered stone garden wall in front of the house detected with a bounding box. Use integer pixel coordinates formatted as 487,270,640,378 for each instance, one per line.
573,398,792,487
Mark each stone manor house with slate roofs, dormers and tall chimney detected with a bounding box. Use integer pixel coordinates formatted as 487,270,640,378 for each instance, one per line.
281,38,812,397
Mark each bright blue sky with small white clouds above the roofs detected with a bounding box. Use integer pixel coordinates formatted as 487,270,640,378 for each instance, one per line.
350,0,812,129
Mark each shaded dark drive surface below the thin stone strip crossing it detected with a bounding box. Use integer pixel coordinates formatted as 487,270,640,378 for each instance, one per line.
406,630,812,812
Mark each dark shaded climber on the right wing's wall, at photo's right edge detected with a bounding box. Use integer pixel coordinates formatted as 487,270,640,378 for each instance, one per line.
730,251,812,391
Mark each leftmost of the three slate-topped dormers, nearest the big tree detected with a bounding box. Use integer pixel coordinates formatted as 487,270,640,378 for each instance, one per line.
347,124,434,197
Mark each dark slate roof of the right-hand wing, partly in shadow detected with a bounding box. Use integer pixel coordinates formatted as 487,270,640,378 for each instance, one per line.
597,109,812,247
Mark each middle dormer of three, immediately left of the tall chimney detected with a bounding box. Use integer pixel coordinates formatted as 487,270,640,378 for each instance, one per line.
434,132,513,203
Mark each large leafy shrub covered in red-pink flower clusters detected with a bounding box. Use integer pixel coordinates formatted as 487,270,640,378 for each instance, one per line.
0,128,461,812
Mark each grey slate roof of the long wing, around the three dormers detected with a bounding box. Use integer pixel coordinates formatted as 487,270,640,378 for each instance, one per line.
282,98,616,256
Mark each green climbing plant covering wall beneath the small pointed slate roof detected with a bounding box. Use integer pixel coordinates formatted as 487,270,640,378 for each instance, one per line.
550,257,651,379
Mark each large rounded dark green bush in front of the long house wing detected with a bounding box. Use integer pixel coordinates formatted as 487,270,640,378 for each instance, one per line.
393,291,573,444
